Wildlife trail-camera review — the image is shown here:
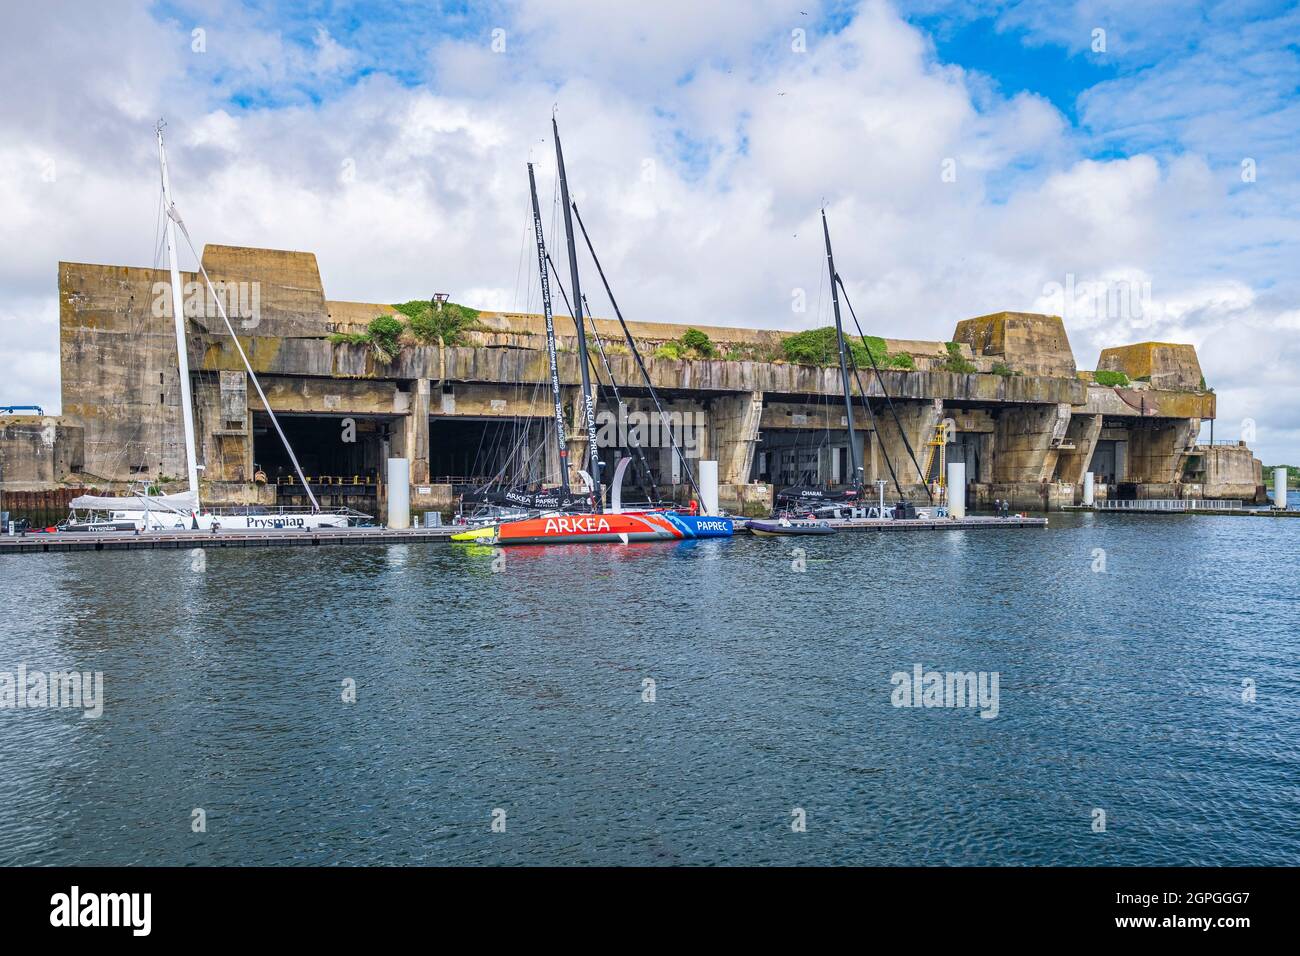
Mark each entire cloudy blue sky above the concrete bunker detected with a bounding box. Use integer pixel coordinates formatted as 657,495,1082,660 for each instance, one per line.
0,0,1300,459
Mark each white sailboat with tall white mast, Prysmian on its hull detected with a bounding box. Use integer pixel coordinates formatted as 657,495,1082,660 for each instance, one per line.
61,121,369,531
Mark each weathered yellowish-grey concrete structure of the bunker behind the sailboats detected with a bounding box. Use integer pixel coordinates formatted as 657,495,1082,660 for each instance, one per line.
35,246,1242,507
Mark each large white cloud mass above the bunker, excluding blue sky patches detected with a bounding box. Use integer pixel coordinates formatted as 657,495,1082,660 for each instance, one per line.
0,0,1300,458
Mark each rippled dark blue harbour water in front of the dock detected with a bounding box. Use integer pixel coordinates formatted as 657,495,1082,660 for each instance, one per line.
0,514,1300,865
